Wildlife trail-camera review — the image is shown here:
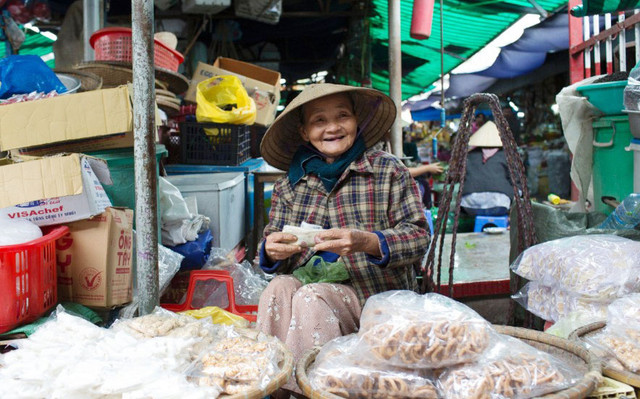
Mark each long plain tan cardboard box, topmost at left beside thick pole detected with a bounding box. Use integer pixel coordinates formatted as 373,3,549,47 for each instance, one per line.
0,86,133,152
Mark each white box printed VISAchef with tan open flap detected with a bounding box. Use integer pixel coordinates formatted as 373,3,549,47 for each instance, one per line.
0,154,113,226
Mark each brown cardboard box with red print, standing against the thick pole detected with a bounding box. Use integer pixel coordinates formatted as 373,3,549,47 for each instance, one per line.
56,208,133,307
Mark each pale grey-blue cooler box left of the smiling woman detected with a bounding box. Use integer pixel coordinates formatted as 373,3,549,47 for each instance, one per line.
166,172,246,250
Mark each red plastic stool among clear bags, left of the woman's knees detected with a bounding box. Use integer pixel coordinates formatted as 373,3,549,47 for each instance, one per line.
160,270,258,322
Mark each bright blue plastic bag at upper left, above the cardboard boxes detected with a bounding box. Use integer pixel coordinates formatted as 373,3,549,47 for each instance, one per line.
0,55,67,98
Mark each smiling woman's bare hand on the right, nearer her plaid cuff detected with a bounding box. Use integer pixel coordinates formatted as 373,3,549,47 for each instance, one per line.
314,229,382,258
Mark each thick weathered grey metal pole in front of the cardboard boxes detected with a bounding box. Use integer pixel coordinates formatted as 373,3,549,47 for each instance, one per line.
131,0,159,315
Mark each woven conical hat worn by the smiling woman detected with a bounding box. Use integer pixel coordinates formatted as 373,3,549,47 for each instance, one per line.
260,83,398,171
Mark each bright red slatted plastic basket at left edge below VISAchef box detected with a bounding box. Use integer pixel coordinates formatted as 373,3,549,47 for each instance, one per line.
0,226,69,333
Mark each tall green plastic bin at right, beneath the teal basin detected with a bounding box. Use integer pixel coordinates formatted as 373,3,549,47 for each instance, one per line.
593,116,633,214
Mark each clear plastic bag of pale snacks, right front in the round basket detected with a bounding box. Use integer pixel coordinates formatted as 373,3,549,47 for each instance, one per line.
437,334,580,399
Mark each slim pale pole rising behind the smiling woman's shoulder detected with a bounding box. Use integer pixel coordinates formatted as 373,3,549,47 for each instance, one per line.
389,0,402,157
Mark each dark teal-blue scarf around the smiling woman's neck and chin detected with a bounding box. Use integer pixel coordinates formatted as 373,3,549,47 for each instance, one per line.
289,136,367,192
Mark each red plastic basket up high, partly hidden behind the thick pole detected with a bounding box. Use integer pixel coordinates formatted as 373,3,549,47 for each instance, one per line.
89,28,184,72
